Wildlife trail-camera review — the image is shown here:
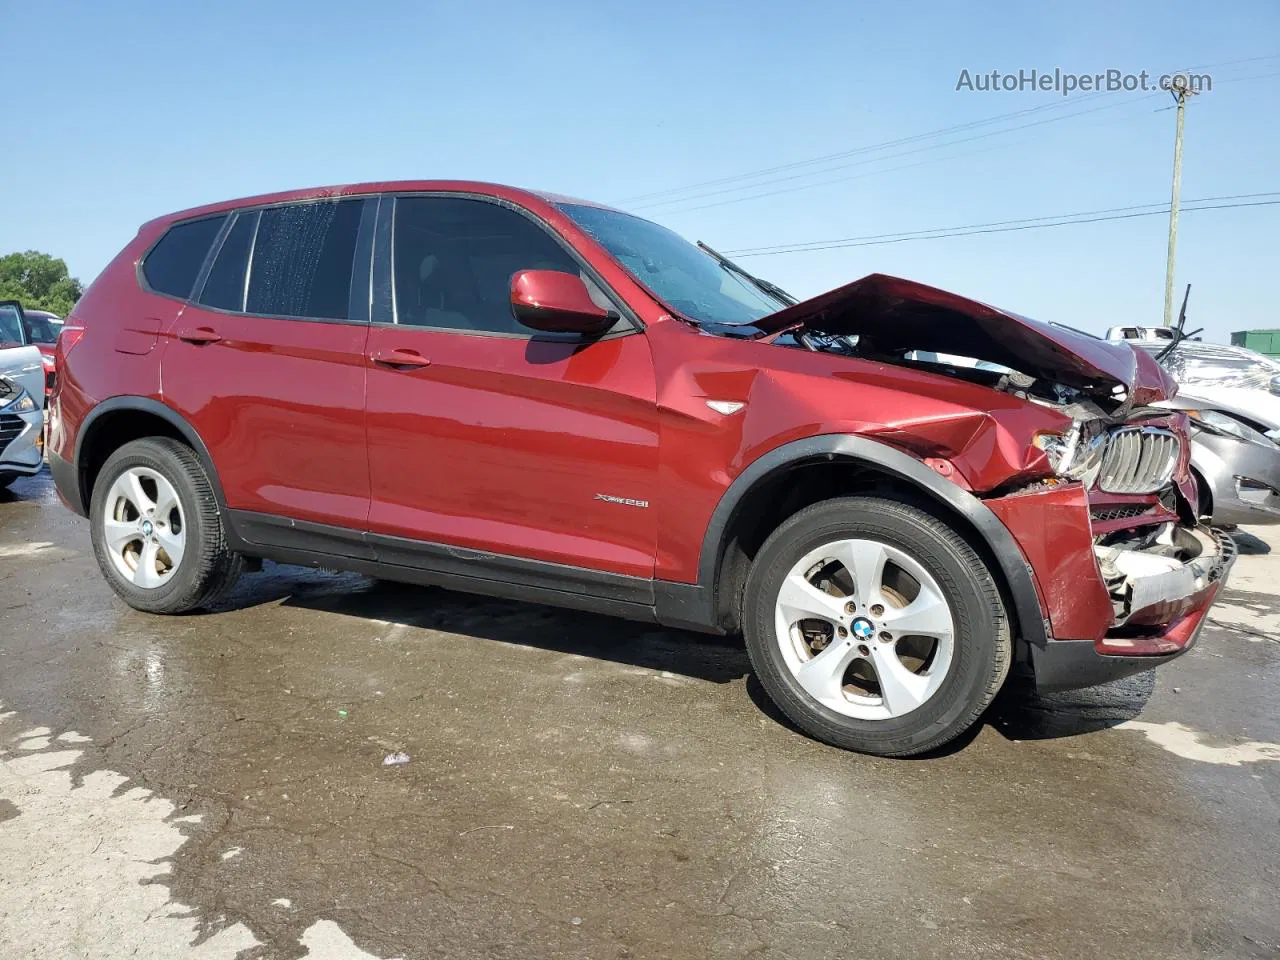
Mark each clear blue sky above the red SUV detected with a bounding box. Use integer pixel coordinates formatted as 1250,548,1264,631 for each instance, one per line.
0,0,1280,339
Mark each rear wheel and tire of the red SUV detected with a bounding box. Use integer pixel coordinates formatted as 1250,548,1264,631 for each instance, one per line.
90,436,244,613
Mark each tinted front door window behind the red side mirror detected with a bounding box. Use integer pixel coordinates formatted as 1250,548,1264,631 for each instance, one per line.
394,197,591,334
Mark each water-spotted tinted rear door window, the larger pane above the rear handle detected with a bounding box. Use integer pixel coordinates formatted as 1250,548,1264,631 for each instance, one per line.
246,200,369,320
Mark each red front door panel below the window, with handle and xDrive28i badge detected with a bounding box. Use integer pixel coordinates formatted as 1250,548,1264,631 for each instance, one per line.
367,326,660,577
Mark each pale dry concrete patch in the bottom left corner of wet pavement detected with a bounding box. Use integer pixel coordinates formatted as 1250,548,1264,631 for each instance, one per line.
0,708,391,960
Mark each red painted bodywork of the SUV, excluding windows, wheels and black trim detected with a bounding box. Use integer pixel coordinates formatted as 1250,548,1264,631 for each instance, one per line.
50,180,1216,691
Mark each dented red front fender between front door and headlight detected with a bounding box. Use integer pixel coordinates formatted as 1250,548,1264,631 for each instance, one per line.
648,320,1070,582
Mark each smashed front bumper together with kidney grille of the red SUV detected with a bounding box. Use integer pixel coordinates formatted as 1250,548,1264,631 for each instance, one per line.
987,416,1235,690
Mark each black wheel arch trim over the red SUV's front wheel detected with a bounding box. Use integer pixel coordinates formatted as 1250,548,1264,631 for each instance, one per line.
698,434,1050,646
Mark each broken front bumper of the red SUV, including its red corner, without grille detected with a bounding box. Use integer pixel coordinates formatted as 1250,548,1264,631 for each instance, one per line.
987,484,1235,691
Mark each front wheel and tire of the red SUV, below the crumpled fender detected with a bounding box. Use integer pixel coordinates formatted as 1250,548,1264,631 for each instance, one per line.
742,497,1012,756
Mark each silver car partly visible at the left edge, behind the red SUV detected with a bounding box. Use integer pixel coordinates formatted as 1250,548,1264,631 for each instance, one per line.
0,301,45,488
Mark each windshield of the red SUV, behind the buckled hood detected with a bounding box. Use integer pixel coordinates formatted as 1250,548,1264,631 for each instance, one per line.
559,204,782,324
